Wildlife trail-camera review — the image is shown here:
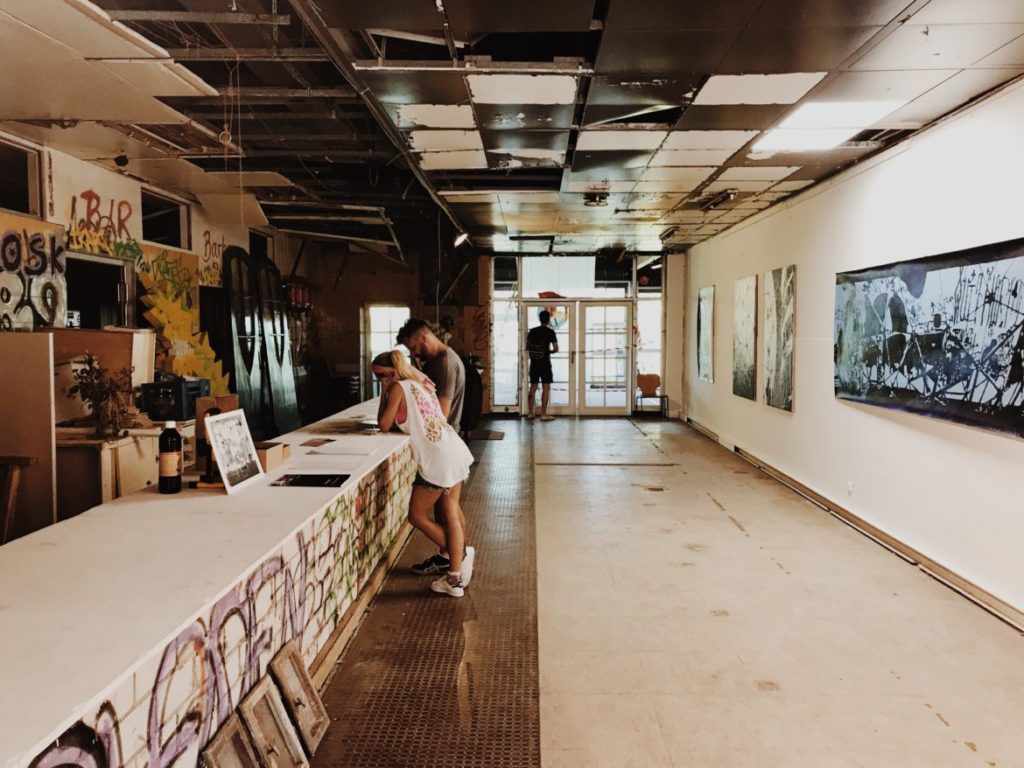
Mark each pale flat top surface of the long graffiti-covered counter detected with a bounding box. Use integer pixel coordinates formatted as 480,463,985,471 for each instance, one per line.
0,401,408,765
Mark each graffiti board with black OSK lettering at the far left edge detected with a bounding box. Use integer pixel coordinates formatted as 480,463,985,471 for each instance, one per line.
0,213,68,331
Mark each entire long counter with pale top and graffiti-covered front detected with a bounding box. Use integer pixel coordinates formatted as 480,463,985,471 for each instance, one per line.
0,402,415,768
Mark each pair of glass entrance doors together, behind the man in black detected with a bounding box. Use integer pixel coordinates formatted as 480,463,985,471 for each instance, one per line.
519,299,633,416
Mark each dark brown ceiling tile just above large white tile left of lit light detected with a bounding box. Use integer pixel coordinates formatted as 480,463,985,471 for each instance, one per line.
716,27,880,75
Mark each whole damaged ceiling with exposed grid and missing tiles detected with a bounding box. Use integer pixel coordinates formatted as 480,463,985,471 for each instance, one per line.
0,0,1024,254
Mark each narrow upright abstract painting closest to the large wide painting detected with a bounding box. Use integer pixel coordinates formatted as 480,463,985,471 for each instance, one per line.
763,264,797,411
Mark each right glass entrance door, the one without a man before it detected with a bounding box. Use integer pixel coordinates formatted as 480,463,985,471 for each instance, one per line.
578,302,633,416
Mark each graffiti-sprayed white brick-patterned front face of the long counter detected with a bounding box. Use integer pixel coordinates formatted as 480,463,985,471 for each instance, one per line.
24,446,407,768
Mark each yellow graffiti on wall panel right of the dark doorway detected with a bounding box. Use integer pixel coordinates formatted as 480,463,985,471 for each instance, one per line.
135,246,229,394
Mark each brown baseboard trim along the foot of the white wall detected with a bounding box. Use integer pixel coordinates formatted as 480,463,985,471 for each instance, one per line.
687,442,1024,632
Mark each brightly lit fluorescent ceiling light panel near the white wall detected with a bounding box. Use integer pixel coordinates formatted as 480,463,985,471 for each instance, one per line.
752,101,906,152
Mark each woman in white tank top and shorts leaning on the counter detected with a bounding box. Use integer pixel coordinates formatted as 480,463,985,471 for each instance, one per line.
371,349,476,597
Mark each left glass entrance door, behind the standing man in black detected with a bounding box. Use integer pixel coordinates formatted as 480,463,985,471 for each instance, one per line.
519,299,577,416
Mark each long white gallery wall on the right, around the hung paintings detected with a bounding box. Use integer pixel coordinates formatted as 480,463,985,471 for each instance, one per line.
669,83,1024,609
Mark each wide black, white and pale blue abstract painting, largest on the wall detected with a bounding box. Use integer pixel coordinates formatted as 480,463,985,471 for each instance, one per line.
835,239,1024,436
